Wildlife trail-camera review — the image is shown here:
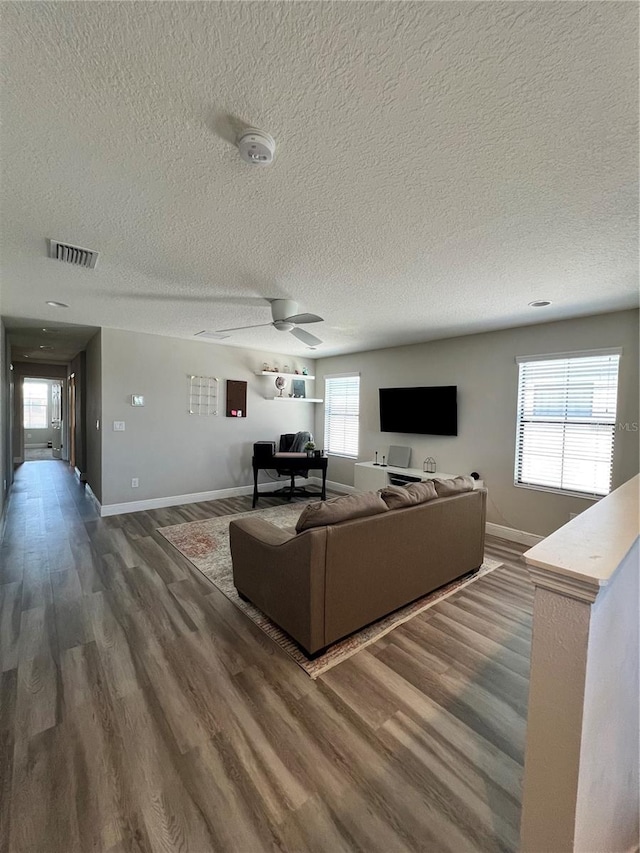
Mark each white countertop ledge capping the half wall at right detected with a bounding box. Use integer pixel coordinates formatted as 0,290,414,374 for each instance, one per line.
523,475,640,599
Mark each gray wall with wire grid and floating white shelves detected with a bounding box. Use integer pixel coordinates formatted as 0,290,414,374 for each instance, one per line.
99,329,315,505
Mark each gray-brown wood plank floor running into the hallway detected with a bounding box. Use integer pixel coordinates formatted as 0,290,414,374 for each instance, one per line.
0,461,532,853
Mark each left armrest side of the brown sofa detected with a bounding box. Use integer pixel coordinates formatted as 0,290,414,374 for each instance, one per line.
229,518,327,654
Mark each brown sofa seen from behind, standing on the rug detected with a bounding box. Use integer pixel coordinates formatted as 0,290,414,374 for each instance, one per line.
229,482,486,655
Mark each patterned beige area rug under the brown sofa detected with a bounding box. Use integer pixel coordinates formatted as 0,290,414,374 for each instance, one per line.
158,503,502,678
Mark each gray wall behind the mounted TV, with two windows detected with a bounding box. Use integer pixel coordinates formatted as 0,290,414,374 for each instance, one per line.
315,311,640,535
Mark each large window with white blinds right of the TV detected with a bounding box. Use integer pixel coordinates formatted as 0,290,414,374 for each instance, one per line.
515,350,620,497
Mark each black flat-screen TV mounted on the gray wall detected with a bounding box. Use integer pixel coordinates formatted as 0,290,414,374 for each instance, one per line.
380,385,458,435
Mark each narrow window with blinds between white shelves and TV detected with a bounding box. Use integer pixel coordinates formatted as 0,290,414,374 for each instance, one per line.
324,374,360,459
